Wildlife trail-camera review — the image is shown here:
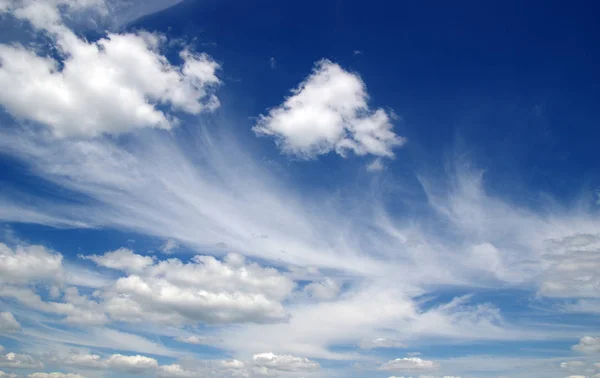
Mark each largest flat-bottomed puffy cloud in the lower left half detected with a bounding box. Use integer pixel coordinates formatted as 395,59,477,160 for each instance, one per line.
104,251,294,324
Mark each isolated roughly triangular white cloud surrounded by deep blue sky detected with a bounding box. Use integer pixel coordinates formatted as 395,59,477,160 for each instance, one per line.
253,60,405,158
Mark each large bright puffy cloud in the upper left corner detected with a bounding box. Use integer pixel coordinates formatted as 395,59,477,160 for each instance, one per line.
0,1,219,136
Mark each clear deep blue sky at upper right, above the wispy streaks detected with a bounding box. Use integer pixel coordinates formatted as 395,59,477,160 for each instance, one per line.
135,1,600,198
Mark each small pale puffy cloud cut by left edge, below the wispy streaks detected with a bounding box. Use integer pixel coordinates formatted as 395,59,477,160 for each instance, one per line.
0,243,63,284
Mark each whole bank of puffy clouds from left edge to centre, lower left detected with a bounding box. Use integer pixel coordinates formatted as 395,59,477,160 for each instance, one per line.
0,244,295,330
